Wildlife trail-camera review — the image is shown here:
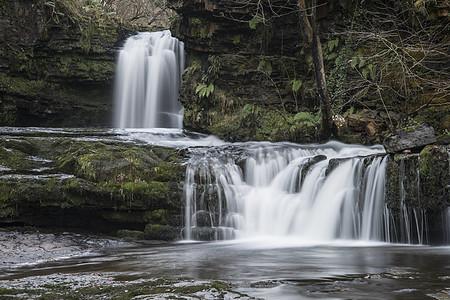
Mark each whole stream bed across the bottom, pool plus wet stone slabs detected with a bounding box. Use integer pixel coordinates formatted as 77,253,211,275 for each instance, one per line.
0,231,450,299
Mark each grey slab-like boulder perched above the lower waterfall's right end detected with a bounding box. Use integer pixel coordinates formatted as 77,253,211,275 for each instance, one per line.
383,126,436,153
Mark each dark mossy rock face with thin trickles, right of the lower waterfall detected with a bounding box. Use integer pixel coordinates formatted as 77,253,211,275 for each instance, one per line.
385,145,450,244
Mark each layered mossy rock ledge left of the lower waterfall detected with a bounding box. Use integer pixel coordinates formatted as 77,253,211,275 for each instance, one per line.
0,132,185,240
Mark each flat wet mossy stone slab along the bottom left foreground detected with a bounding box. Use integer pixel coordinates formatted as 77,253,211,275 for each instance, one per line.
0,273,253,300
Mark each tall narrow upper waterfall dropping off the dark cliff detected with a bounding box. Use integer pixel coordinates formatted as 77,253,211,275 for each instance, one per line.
114,30,184,128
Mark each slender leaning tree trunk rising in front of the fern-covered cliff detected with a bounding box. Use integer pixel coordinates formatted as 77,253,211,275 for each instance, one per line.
297,0,336,139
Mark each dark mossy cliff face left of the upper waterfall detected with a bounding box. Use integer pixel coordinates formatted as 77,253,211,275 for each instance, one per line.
0,0,123,127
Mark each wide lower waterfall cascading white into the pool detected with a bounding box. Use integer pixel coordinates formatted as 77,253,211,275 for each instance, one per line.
183,142,423,242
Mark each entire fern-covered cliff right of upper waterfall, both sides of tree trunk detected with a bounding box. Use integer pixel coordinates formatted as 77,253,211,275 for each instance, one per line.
169,0,449,143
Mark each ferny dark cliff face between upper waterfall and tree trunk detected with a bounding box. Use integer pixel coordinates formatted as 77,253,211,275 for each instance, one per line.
172,1,314,140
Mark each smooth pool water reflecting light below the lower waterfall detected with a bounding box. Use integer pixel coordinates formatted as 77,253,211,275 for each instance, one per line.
2,240,450,299
